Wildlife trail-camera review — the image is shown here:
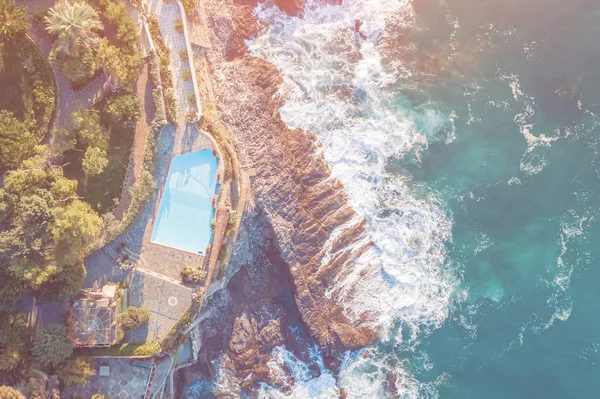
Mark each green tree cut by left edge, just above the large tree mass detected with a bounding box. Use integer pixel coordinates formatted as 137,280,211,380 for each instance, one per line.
0,109,36,170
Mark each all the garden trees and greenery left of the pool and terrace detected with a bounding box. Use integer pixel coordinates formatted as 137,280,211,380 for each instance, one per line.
0,0,174,398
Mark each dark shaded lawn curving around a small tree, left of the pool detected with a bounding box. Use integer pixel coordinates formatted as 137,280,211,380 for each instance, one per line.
64,94,135,213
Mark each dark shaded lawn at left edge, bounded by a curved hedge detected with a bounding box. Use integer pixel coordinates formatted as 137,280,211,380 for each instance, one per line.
0,36,56,141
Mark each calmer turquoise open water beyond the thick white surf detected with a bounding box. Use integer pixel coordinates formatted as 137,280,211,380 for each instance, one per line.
396,0,600,399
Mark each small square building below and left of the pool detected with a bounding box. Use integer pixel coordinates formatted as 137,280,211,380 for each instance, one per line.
72,285,118,348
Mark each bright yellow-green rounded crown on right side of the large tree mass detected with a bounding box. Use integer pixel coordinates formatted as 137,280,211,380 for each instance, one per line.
50,200,102,265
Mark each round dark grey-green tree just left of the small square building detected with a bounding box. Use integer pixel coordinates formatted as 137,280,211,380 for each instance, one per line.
33,323,73,365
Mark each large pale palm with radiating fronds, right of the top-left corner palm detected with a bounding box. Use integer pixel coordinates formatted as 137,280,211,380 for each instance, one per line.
45,0,103,57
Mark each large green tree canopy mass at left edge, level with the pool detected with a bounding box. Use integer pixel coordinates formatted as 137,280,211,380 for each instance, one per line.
0,146,103,302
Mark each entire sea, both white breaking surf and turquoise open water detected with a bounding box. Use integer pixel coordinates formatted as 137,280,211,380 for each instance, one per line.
248,0,600,399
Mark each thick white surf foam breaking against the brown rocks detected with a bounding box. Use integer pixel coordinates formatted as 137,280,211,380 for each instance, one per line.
248,0,456,397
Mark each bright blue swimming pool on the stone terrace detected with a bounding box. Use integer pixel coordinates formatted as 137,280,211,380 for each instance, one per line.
150,148,218,254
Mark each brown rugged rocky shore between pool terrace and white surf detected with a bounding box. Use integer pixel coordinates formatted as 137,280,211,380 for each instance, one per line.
176,0,378,397
